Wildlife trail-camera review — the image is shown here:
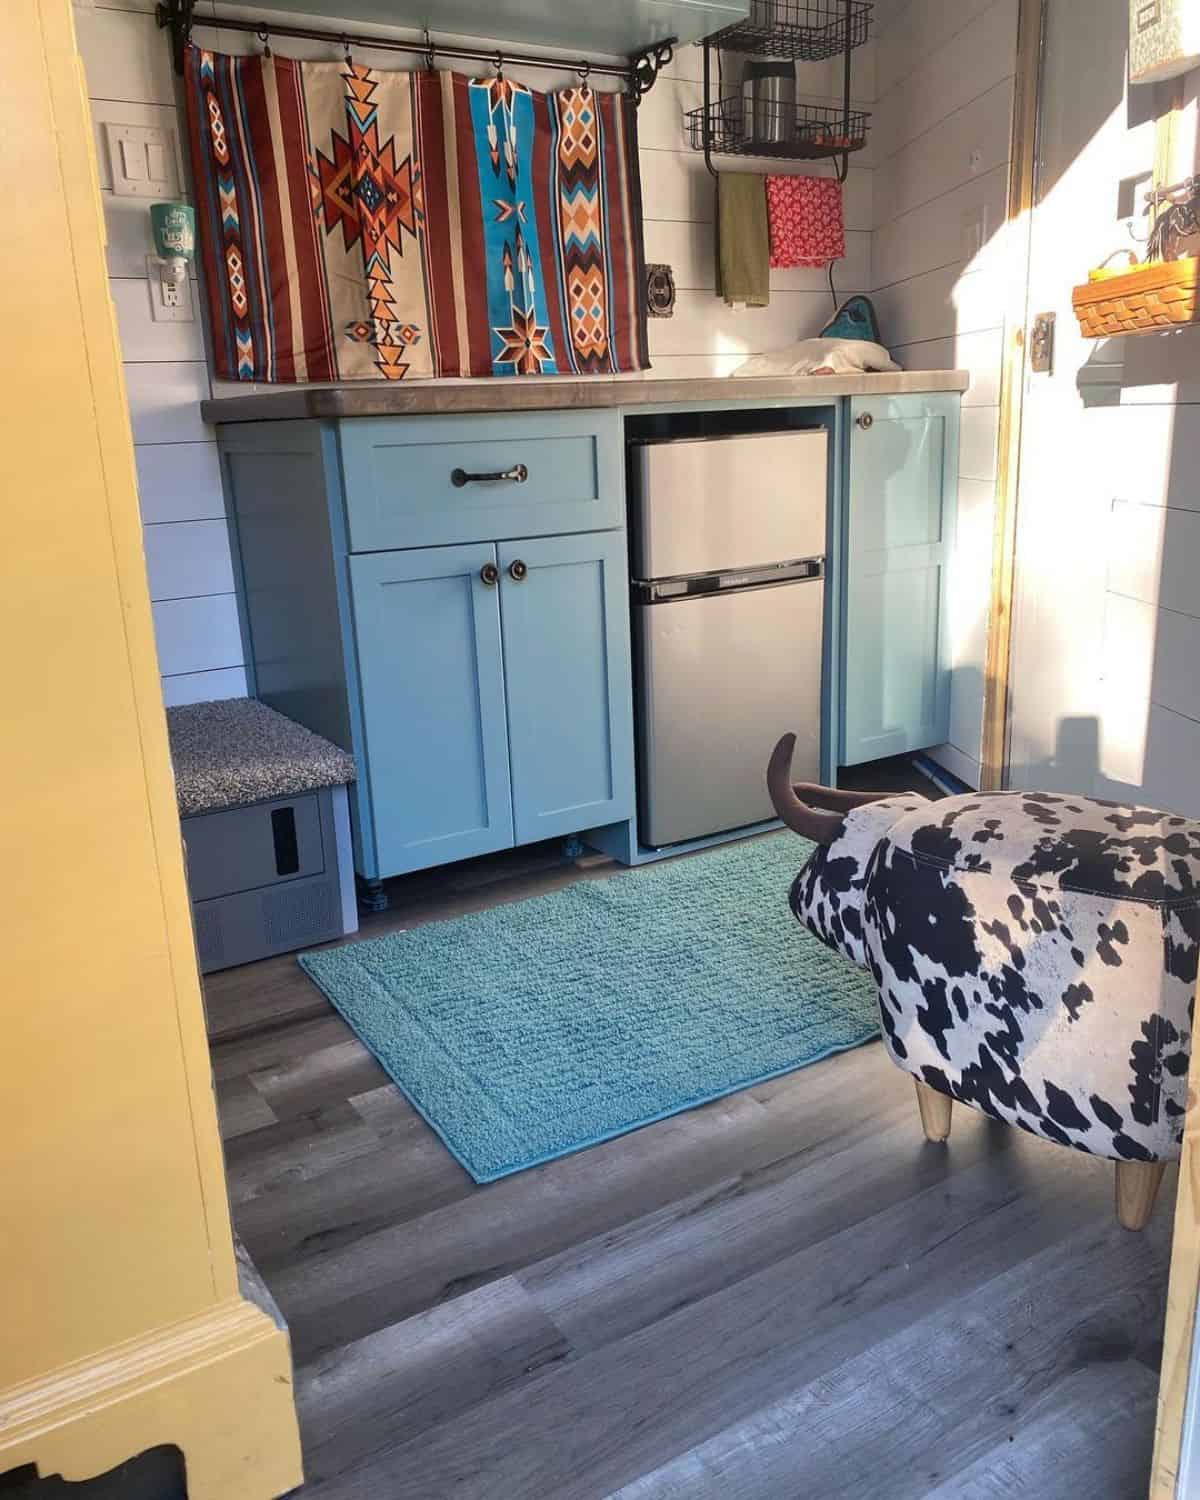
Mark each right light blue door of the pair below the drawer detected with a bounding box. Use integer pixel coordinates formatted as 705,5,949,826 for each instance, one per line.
498,531,633,845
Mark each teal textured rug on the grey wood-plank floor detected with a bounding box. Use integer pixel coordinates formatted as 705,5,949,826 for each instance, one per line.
300,834,879,1182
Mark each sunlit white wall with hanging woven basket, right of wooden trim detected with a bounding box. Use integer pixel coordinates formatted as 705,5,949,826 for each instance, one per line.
1011,0,1200,818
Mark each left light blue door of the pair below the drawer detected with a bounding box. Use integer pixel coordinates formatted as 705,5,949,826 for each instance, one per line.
348,542,513,876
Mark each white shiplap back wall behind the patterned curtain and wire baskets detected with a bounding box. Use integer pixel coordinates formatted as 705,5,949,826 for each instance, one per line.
75,0,875,704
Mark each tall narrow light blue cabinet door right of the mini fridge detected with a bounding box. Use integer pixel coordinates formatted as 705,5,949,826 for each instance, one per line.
842,395,959,765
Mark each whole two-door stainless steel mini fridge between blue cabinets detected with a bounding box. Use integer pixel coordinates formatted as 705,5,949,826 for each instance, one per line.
630,429,828,848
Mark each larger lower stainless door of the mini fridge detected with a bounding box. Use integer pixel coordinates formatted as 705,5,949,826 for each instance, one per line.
633,581,825,848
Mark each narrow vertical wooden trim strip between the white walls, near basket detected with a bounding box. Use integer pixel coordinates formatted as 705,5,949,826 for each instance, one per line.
980,0,1044,792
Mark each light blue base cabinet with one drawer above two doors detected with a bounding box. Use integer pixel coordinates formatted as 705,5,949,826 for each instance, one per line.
221,411,635,900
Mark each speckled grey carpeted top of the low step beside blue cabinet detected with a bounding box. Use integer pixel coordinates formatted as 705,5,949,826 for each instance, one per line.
167,698,354,818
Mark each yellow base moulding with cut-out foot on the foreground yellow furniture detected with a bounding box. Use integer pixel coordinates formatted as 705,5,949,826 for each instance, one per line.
0,1296,303,1500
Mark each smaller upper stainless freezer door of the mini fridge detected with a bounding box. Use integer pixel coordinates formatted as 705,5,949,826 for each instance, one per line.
632,431,828,579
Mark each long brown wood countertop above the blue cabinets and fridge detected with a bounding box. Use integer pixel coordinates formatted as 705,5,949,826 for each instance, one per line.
200,371,971,423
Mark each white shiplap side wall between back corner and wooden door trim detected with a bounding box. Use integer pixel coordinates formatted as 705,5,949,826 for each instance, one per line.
872,0,1017,786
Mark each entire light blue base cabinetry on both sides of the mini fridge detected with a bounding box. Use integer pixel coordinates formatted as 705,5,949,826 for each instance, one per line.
221,393,959,897
